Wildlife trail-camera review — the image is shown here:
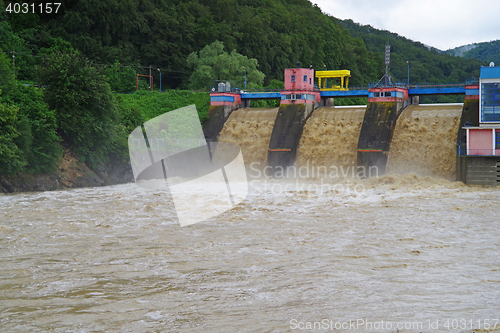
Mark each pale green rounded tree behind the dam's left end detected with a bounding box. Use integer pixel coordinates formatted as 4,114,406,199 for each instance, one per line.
187,41,265,89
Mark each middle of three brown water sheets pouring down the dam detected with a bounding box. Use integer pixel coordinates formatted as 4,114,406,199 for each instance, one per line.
296,105,366,169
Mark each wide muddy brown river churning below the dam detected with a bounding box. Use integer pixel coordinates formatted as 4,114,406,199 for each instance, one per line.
0,175,500,332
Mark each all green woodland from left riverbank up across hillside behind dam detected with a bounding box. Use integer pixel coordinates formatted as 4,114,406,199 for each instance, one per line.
0,0,492,182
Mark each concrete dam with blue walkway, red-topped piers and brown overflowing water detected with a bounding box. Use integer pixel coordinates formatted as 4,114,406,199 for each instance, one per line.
204,67,500,185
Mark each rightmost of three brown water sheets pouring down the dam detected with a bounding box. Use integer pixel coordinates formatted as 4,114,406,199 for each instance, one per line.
387,104,463,180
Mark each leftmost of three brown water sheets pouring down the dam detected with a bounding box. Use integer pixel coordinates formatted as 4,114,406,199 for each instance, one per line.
218,108,278,169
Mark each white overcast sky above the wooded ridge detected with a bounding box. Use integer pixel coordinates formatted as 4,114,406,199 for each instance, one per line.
310,0,500,50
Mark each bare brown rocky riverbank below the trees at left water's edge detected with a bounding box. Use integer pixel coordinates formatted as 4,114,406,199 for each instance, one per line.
0,149,134,193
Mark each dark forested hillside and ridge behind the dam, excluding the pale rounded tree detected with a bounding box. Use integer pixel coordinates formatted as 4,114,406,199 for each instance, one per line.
2,0,482,88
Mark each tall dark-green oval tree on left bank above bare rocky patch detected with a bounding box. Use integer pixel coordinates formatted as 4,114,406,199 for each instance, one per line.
38,52,118,164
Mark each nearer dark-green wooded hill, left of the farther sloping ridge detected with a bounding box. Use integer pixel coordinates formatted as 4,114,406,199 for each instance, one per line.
2,0,380,88
